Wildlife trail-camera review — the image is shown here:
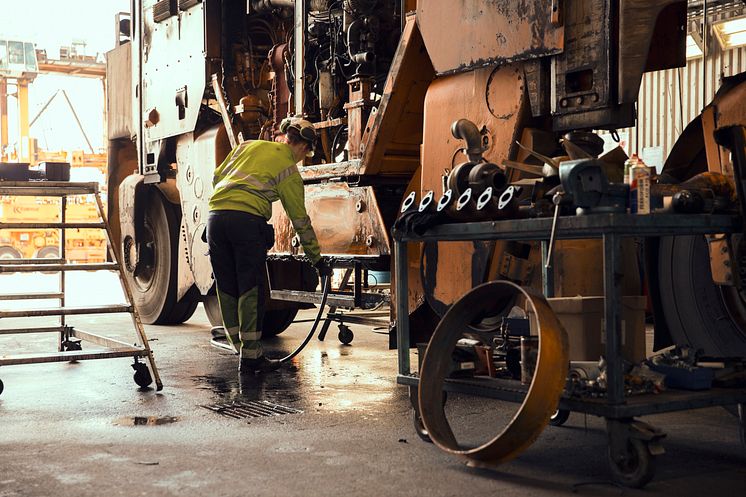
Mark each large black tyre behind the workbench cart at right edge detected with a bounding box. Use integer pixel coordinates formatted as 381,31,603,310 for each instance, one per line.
658,236,746,357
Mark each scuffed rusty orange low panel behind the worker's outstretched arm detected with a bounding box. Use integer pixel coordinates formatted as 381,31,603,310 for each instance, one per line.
270,183,391,256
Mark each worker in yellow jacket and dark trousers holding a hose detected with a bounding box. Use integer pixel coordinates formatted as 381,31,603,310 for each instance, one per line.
207,118,332,373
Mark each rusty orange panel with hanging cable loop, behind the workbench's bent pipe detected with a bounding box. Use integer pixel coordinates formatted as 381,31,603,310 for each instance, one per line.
420,64,530,312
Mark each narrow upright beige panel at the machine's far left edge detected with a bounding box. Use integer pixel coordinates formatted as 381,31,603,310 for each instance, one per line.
106,43,132,140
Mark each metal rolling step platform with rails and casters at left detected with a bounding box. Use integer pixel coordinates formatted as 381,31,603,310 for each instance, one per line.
0,181,163,393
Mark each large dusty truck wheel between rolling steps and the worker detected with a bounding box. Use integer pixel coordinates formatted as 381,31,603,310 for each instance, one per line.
122,191,199,325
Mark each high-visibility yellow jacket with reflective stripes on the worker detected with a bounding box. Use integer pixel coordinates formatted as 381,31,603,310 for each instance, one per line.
210,140,321,264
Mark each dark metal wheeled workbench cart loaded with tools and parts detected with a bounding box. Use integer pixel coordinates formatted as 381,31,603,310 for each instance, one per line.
394,214,746,486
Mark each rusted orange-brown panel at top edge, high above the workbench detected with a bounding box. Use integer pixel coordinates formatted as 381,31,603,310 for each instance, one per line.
417,0,564,74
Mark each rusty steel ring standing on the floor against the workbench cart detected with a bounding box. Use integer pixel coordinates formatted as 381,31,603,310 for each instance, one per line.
419,281,569,465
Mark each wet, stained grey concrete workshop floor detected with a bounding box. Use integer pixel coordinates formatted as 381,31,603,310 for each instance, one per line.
0,274,746,497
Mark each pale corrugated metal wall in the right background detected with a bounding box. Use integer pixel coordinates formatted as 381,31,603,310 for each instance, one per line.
620,4,746,161
